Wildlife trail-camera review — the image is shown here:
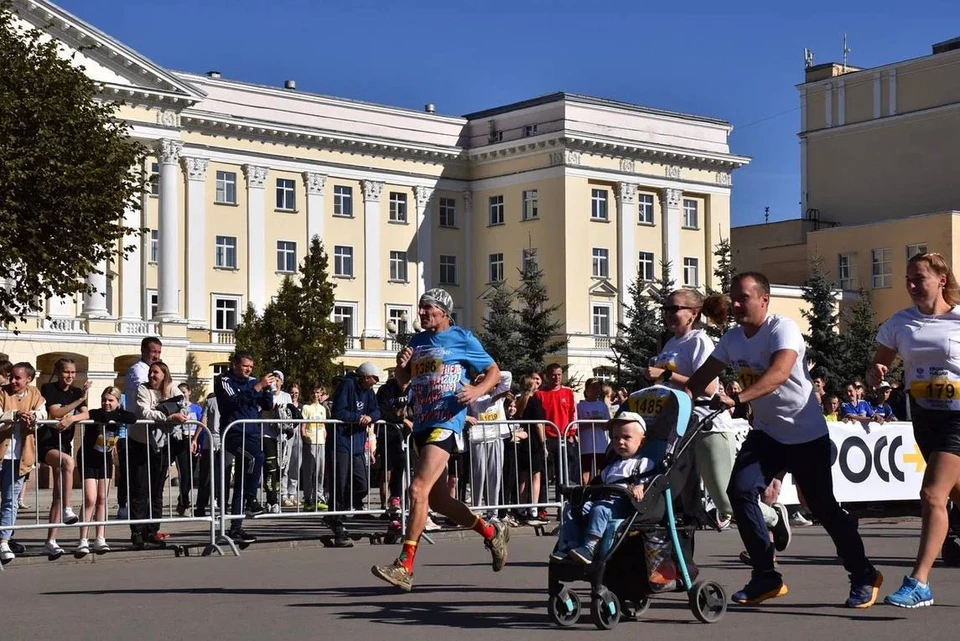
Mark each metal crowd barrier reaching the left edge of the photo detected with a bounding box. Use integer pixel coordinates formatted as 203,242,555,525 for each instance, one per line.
0,420,223,567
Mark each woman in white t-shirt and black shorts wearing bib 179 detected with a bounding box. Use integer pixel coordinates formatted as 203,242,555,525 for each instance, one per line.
867,253,960,608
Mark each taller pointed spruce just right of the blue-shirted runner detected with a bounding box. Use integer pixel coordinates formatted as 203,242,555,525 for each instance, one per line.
513,261,567,375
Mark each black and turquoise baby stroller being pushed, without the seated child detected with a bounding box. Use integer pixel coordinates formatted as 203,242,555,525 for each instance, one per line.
548,384,727,630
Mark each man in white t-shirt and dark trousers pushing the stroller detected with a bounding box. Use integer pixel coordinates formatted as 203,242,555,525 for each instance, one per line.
687,272,883,608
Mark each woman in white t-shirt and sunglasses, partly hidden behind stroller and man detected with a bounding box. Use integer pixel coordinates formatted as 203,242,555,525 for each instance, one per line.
645,289,736,528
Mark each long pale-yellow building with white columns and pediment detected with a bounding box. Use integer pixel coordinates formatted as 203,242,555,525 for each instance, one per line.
0,0,748,390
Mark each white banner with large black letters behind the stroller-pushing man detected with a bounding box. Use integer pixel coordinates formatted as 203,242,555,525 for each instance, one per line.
734,421,926,505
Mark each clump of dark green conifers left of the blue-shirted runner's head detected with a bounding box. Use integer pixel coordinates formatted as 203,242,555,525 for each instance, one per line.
235,236,346,385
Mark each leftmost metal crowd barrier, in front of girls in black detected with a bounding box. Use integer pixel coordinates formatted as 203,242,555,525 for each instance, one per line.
0,420,223,568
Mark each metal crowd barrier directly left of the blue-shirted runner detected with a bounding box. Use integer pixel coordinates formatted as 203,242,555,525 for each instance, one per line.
218,418,409,554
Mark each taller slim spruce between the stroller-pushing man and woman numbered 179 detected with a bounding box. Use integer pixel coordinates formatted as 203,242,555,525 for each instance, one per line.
802,257,847,390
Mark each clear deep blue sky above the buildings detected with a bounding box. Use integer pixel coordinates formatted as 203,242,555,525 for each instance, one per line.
59,0,960,225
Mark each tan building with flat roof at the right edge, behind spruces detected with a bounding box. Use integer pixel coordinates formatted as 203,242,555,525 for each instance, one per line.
731,34,960,320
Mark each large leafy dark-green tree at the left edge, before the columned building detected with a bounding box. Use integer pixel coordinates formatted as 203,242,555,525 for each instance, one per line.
0,7,145,324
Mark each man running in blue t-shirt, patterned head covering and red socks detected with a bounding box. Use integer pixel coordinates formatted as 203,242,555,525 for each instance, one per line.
371,289,510,592
